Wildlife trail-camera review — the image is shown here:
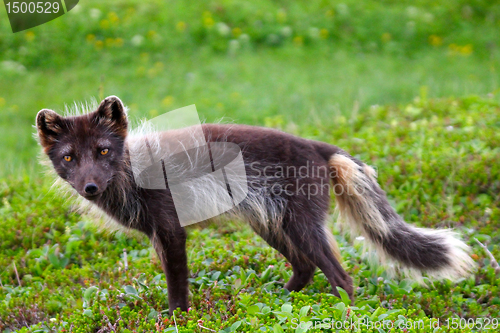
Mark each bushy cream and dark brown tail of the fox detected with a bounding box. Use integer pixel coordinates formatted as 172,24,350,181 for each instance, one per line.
329,151,475,280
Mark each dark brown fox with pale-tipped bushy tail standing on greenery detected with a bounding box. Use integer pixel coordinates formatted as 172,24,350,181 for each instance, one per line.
35,96,475,315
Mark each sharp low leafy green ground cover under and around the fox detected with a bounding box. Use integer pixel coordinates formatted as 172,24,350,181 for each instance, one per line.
0,96,500,332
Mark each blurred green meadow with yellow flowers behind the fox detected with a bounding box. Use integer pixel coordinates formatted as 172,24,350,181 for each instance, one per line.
0,0,500,175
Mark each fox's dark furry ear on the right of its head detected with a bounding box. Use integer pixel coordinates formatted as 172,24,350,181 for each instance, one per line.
96,96,128,137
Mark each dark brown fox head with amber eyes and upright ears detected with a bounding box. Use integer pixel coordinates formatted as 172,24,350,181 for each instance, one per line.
36,96,128,200
